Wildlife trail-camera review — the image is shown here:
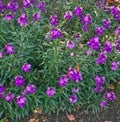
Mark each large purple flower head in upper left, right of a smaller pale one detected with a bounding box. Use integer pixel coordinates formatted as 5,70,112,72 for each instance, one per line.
18,13,28,26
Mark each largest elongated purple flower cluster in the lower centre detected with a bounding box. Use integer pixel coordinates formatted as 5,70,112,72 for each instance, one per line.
68,67,83,83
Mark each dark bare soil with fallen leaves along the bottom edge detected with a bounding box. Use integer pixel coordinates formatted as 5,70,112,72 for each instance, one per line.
10,92,120,122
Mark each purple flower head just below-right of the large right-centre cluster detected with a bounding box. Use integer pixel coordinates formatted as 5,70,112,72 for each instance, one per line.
96,52,107,64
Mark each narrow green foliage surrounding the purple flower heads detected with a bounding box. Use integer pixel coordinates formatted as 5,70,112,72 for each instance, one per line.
0,0,120,119
